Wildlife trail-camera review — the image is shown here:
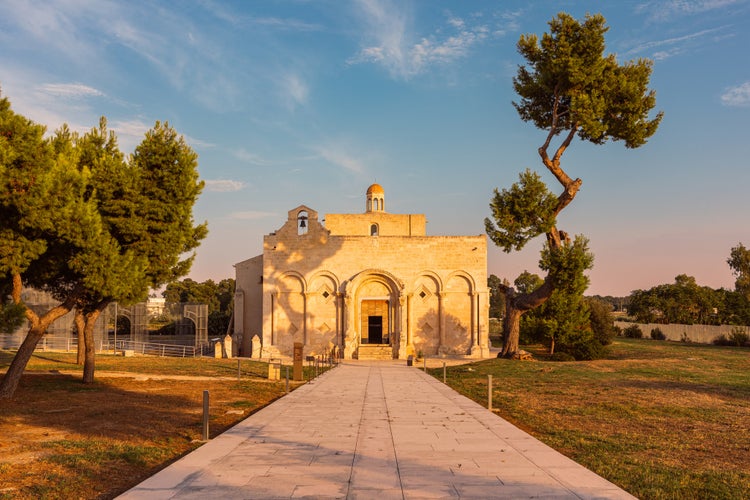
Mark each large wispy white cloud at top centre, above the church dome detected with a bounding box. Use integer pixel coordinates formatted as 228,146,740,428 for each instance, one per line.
348,0,490,80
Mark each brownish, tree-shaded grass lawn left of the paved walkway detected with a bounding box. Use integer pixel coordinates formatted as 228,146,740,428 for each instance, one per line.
0,351,306,499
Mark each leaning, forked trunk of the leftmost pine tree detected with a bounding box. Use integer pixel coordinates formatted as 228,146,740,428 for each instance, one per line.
0,274,73,399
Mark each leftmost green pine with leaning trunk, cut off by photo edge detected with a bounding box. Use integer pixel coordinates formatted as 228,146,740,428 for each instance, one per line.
0,98,102,398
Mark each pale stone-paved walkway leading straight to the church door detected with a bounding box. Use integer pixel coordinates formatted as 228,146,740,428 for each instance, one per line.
120,361,633,500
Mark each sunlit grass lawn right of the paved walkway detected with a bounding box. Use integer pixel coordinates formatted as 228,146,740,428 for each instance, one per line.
430,338,750,499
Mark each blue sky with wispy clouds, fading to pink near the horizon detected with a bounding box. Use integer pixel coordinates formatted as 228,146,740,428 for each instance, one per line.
0,0,750,295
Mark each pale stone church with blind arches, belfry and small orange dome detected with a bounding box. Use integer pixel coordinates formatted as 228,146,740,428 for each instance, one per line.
235,184,489,359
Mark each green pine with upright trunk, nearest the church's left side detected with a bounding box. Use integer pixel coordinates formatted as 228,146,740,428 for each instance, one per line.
72,119,207,383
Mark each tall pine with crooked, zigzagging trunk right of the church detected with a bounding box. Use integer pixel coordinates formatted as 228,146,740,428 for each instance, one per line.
485,13,662,357
